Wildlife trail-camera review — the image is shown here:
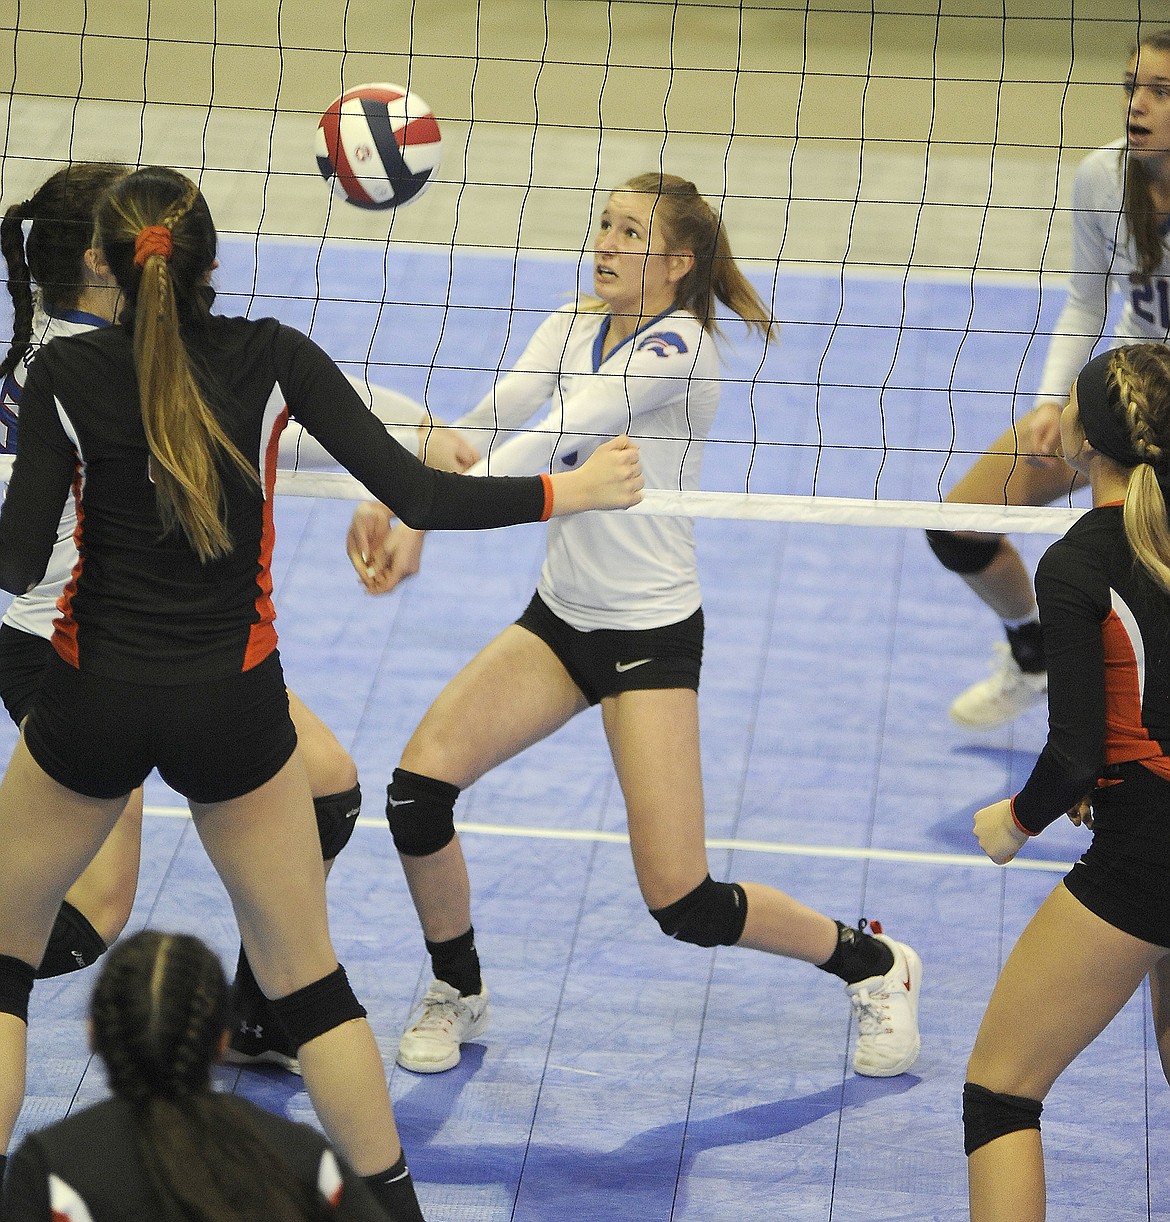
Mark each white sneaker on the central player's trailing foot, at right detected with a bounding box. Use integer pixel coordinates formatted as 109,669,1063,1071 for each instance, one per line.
845,934,922,1078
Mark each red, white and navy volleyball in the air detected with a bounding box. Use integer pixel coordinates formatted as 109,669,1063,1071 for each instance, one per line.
317,84,443,209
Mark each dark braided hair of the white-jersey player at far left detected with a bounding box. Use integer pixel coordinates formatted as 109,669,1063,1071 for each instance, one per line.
0,161,128,378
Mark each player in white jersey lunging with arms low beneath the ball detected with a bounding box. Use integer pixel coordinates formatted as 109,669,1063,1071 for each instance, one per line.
348,174,922,1077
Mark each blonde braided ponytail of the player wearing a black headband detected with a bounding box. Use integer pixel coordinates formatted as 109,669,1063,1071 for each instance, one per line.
1108,343,1170,594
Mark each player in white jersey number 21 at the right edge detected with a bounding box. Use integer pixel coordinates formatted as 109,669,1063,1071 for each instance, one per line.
927,29,1170,730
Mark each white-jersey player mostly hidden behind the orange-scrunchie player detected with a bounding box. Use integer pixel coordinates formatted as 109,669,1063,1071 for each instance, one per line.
0,163,478,1069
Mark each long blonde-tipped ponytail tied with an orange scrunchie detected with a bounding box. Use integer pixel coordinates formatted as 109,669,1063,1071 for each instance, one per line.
94,166,259,562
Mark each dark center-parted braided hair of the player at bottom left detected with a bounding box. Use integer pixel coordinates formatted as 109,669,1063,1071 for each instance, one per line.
89,930,330,1222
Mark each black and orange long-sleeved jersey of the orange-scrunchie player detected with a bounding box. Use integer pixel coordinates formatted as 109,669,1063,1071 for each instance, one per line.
0,316,545,684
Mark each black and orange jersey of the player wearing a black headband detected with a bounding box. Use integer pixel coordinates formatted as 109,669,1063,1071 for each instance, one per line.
1012,505,1170,832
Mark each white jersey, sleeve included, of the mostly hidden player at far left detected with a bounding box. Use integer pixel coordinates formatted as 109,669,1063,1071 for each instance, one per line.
0,310,429,639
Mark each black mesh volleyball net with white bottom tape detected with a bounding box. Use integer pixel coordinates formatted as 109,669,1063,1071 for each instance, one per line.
0,0,1150,533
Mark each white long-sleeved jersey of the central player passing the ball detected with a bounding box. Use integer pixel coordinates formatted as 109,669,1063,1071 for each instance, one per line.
456,306,719,631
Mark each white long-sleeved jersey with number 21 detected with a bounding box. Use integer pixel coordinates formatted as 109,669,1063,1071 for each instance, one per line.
1038,141,1170,403
